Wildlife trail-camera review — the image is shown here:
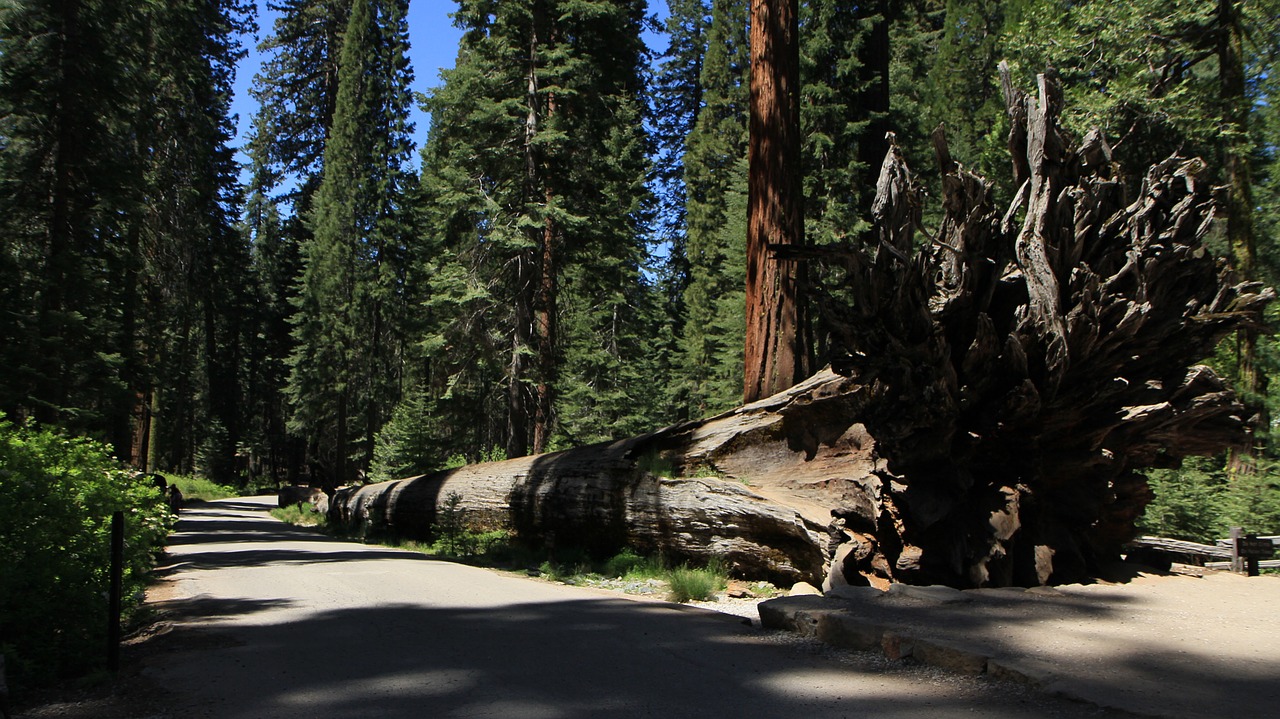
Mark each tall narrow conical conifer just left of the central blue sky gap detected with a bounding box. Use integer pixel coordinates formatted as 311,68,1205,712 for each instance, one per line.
288,0,412,482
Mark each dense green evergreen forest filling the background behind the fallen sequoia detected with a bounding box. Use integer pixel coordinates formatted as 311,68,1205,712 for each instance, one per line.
0,0,1280,539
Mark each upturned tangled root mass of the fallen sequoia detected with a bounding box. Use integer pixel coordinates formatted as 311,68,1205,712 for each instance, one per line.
777,64,1275,586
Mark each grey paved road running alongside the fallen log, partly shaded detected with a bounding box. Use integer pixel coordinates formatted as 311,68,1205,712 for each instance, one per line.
145,498,1119,719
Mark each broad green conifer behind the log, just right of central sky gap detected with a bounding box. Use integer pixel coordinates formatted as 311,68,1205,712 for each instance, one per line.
422,0,649,457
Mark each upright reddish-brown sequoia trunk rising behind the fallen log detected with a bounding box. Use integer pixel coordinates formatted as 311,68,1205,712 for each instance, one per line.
742,0,810,402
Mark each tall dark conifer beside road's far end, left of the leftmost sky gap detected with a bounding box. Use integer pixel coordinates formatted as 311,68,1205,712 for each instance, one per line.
137,0,252,482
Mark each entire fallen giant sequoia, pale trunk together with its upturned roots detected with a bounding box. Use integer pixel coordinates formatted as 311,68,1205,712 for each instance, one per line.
330,74,1274,587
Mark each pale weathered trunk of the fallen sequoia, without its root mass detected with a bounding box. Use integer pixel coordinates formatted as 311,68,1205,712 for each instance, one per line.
330,371,872,583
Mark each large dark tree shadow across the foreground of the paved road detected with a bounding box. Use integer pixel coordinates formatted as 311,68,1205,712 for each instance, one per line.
140,599,1116,719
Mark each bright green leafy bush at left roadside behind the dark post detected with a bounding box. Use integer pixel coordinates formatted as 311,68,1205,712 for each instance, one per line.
0,417,172,687
